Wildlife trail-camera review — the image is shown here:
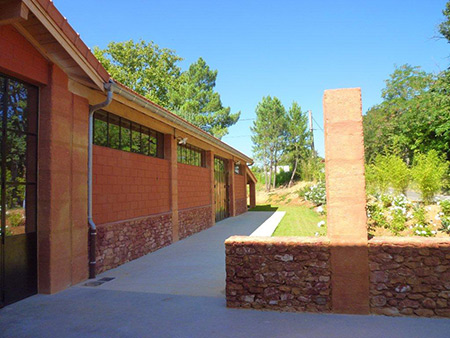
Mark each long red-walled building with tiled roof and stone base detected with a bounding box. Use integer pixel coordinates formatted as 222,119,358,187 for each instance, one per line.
0,0,256,306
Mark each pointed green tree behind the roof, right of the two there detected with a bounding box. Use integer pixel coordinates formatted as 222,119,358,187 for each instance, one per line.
170,58,240,138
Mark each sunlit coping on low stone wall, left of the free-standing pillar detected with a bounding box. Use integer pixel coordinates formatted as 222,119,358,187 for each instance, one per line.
225,236,330,246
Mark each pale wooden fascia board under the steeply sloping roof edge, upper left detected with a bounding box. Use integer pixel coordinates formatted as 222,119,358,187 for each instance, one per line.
23,0,104,91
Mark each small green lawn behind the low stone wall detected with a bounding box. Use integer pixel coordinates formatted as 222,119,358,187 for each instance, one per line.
250,205,327,237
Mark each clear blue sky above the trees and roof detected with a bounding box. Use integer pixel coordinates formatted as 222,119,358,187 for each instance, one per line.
54,0,450,159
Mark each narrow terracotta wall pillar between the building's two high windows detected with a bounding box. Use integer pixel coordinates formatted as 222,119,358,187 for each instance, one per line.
164,134,179,242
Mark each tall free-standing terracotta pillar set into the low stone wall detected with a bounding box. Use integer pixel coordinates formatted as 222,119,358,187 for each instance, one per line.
323,88,369,314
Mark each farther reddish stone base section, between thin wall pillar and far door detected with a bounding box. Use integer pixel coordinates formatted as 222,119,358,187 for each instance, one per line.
178,205,213,239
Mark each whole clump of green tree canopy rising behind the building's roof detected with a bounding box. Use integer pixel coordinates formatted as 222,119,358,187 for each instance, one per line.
94,40,240,138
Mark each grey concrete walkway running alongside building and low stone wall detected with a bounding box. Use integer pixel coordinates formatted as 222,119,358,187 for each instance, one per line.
0,212,450,338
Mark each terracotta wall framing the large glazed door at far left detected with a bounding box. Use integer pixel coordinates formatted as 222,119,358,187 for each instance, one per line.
0,26,89,293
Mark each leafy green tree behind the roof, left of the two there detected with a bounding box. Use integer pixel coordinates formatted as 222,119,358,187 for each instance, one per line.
94,40,182,108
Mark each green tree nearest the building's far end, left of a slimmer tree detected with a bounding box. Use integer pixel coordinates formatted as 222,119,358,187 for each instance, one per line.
250,96,286,190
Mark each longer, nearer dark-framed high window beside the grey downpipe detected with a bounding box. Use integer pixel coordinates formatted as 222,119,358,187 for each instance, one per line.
94,110,164,158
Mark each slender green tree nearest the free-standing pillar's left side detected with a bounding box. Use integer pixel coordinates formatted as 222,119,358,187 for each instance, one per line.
285,102,311,187
